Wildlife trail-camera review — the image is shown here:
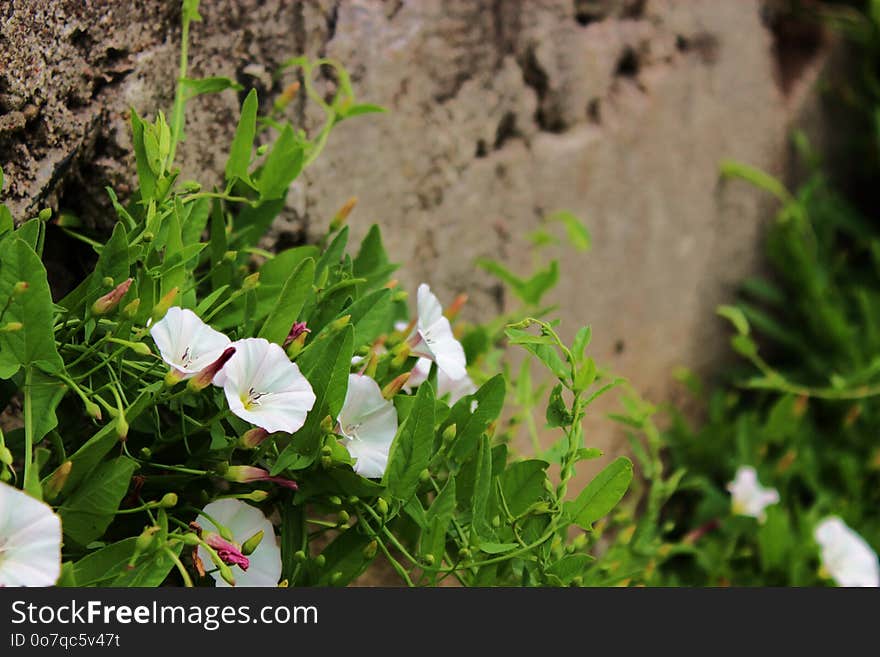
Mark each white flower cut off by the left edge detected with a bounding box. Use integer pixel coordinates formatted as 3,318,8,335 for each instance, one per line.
0,483,61,587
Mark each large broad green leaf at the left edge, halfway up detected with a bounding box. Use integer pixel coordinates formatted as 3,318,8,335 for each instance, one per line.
0,237,64,379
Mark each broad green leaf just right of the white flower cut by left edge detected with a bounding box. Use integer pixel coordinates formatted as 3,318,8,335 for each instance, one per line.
58,456,137,545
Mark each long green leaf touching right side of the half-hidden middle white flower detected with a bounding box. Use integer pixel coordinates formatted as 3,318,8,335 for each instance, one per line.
384,385,434,501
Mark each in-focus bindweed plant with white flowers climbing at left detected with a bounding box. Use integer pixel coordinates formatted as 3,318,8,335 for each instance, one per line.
0,0,632,586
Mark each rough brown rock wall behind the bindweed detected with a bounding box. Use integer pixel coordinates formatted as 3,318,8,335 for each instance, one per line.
0,0,827,462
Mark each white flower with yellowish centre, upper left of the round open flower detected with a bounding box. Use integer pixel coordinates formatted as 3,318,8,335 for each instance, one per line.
150,306,230,379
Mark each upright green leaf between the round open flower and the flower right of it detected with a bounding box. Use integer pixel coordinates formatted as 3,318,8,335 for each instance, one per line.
272,326,354,468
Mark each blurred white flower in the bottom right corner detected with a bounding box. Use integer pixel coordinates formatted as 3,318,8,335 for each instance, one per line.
813,516,880,586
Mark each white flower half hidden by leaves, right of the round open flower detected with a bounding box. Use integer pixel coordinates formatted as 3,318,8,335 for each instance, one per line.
337,374,397,479
